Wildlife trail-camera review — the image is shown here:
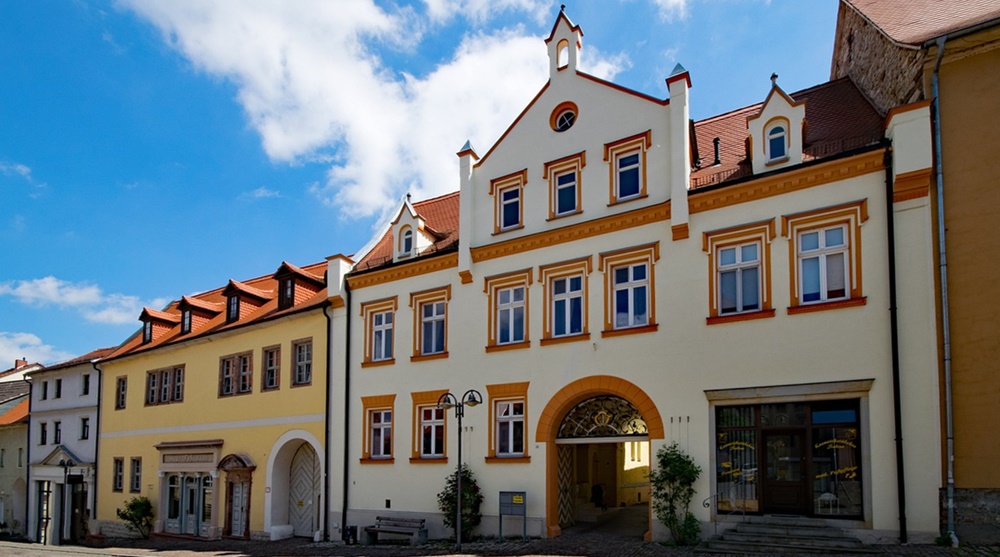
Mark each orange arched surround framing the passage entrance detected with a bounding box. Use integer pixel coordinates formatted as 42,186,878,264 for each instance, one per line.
535,375,664,537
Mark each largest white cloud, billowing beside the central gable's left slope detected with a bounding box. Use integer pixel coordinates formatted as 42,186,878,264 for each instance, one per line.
123,0,623,222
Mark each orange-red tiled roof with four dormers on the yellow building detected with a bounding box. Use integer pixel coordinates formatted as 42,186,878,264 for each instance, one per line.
105,261,328,359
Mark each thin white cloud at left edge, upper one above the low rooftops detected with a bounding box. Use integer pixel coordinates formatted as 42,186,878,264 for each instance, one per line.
0,276,169,325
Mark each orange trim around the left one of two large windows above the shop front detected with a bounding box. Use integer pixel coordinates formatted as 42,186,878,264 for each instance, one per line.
701,219,777,325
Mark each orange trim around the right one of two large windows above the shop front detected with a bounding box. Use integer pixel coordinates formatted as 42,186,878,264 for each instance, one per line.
781,199,868,306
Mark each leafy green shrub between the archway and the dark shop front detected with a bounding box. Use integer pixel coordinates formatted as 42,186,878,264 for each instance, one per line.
649,442,701,545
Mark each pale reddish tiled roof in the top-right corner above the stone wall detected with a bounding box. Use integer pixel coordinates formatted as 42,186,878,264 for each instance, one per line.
843,0,1000,46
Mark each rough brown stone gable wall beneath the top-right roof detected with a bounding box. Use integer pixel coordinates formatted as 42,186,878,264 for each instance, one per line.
830,3,924,114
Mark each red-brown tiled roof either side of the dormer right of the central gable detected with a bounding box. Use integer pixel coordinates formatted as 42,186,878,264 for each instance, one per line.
691,77,883,189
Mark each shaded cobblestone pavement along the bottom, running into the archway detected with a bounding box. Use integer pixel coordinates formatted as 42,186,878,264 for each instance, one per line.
0,508,1000,557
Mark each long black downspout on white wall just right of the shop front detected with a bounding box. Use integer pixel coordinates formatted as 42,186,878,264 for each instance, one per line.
883,143,907,544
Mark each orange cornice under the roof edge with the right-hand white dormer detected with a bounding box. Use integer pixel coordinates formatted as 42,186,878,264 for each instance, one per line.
688,149,884,214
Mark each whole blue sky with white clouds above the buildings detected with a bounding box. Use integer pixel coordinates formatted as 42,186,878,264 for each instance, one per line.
0,0,837,362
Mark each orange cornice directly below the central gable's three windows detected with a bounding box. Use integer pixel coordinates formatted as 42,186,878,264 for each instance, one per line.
468,201,670,262
